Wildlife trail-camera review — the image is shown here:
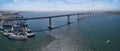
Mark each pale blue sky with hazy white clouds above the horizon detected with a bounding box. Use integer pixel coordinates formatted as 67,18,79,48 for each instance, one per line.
0,0,120,11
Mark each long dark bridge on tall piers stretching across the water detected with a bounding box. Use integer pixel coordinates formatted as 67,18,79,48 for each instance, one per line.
0,12,103,30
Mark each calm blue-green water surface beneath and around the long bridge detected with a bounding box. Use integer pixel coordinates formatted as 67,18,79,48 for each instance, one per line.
0,12,120,51
